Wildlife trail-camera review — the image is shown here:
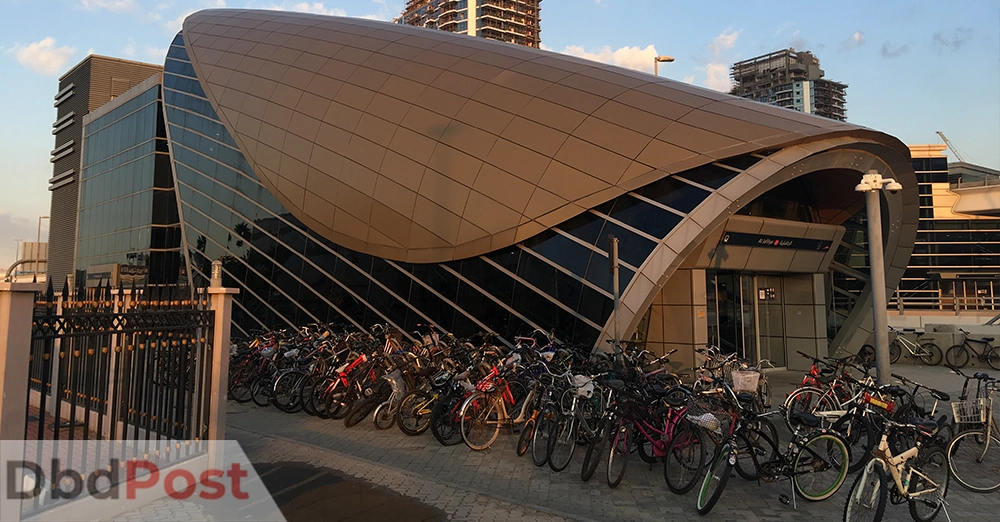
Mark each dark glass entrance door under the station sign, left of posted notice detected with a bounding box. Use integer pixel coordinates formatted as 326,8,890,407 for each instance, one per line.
706,271,758,360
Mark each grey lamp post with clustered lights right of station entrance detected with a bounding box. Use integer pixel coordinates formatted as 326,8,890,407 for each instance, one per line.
854,170,903,385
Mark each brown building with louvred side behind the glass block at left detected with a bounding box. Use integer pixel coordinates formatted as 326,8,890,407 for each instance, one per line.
48,55,163,282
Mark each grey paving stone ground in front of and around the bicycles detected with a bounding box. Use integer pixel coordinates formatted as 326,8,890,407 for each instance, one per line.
227,367,1000,521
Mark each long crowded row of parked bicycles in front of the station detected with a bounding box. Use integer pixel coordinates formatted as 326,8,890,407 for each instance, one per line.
229,325,1000,522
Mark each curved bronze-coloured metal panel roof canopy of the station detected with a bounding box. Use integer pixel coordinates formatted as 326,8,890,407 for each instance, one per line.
184,9,908,262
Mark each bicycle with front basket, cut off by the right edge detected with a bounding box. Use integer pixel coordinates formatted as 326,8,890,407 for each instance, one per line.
947,364,1000,493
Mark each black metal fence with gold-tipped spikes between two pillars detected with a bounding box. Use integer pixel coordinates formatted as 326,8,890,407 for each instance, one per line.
25,284,215,441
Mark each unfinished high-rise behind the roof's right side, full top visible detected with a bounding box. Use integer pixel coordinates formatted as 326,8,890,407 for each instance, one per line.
730,49,847,121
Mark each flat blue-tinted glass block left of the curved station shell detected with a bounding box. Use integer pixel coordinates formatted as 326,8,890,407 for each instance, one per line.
76,85,183,284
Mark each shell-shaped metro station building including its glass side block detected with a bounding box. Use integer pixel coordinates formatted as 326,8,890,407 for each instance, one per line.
64,9,918,367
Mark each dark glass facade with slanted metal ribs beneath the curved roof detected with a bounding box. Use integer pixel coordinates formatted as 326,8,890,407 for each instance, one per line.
163,35,759,344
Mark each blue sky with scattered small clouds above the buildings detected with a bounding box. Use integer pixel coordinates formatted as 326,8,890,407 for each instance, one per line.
0,0,1000,271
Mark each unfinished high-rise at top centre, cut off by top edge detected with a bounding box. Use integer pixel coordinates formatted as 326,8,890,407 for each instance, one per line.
393,0,542,49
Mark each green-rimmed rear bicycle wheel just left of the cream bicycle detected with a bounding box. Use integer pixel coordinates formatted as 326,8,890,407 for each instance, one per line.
792,433,851,502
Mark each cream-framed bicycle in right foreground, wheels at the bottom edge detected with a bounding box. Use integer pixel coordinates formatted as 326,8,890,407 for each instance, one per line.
844,418,951,522
